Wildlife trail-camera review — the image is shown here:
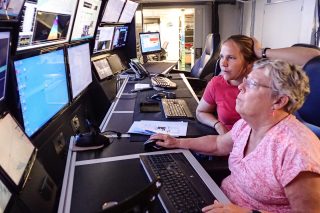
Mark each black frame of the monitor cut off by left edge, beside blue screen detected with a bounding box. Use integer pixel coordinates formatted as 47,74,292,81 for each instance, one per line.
0,27,12,115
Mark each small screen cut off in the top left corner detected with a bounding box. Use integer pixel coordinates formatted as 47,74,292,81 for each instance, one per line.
0,0,25,20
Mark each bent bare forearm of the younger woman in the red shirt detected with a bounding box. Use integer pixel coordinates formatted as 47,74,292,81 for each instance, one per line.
196,98,228,135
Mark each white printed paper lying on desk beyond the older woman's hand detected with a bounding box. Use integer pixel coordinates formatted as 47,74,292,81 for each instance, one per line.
128,120,188,136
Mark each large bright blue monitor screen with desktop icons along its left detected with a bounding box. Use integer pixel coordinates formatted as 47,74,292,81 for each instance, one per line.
14,50,69,136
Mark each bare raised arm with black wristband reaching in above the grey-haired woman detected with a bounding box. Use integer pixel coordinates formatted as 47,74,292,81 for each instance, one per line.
253,38,320,66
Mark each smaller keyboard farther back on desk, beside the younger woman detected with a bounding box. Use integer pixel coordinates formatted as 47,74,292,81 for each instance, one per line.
161,99,193,118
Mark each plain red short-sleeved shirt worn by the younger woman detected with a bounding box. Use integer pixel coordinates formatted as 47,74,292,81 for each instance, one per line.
203,75,240,130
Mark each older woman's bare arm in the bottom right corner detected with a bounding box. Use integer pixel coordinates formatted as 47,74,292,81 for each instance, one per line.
284,172,320,212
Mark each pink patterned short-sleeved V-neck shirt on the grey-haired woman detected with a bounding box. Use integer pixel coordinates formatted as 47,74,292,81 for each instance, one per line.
222,115,320,212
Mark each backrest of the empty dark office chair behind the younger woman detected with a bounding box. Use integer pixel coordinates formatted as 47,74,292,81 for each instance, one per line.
190,34,220,79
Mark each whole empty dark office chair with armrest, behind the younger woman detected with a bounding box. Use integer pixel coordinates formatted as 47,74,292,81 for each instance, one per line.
170,34,220,96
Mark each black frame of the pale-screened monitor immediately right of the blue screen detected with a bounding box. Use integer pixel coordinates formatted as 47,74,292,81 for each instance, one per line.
64,40,94,102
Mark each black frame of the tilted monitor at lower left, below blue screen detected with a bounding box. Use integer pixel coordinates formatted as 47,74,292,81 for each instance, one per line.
0,112,38,193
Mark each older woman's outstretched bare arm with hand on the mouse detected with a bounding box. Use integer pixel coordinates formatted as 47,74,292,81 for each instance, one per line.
150,132,233,156
